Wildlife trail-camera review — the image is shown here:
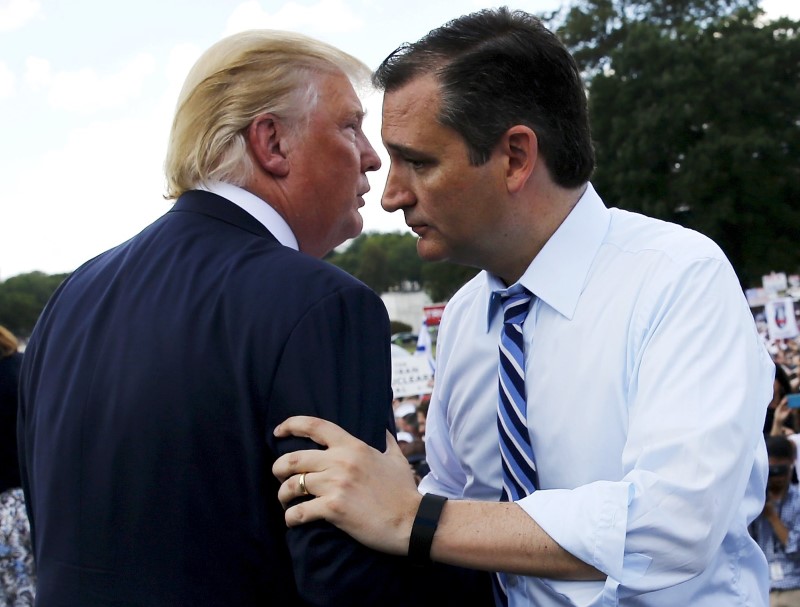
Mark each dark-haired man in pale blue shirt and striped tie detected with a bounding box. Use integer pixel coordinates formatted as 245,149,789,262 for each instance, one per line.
273,8,775,607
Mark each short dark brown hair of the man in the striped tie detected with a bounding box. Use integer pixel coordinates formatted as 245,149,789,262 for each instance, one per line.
372,7,595,188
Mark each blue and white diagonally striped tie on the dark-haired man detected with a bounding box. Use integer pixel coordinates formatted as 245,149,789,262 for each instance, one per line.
495,284,539,605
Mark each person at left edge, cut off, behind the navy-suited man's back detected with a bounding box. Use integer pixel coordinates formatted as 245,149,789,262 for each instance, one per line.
0,325,36,607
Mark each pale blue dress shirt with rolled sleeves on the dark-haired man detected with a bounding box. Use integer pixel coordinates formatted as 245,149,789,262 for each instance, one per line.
419,185,774,607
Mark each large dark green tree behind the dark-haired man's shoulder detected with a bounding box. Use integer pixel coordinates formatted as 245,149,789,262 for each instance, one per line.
558,0,800,287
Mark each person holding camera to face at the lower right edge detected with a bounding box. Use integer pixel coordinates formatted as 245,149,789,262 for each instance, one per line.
751,436,800,607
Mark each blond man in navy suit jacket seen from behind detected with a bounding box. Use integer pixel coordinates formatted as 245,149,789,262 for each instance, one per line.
19,30,491,607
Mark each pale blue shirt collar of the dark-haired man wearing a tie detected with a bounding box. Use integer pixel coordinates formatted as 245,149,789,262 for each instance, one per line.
486,183,611,329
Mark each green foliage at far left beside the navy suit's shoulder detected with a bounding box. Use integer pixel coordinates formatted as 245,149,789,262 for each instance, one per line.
0,272,67,339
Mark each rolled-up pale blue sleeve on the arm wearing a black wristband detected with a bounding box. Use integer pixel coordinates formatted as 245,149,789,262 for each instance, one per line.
519,259,774,597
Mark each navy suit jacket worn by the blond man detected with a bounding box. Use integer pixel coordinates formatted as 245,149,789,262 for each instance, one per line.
19,191,490,607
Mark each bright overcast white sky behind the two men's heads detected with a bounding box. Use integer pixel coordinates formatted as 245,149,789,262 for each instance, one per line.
0,0,800,280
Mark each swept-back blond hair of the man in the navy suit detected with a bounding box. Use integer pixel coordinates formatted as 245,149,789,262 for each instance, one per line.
164,30,370,199
